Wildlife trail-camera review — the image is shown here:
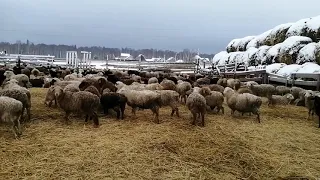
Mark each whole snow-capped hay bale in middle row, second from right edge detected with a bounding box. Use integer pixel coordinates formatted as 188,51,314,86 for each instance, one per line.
279,36,312,64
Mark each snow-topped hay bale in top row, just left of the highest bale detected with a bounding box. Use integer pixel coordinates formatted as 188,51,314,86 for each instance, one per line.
266,23,293,46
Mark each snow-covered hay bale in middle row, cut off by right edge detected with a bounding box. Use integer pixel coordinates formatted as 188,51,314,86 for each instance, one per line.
296,43,320,64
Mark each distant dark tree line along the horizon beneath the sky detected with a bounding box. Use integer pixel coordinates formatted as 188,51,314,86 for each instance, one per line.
0,40,214,61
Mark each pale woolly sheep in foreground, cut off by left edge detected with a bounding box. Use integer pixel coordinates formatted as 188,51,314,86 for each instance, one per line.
0,96,23,138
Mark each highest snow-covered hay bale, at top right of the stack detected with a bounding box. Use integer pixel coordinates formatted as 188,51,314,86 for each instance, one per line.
286,16,320,42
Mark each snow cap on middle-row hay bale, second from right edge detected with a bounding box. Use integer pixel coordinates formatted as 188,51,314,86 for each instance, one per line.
280,36,312,55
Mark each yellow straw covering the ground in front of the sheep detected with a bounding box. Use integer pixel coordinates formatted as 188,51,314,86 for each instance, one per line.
0,89,320,179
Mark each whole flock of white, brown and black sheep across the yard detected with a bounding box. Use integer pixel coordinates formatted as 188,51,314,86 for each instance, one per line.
0,68,320,138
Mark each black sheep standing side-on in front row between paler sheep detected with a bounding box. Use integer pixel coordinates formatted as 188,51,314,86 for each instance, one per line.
100,92,128,119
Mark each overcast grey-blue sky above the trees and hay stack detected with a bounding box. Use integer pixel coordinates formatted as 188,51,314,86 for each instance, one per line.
0,0,320,53
